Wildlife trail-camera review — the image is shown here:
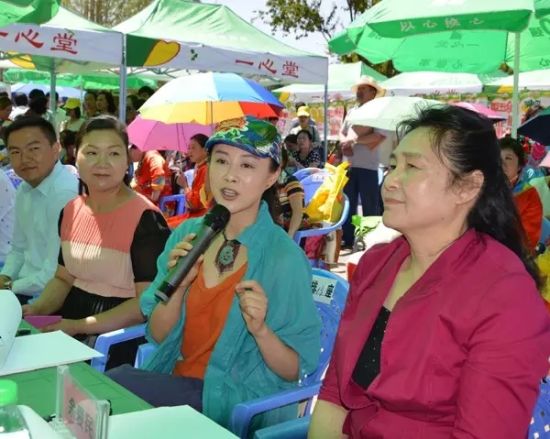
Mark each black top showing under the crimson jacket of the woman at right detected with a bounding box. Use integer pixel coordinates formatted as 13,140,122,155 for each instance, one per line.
352,307,390,389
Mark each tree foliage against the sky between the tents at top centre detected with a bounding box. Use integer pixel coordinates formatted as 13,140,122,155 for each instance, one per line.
255,0,380,40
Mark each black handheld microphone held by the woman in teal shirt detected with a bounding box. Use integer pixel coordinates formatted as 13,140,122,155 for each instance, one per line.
155,204,231,302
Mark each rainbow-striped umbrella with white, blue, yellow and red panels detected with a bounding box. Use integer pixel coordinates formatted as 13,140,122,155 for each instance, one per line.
139,72,283,126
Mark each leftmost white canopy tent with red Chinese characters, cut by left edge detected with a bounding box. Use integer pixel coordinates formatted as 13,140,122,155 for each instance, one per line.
0,7,123,115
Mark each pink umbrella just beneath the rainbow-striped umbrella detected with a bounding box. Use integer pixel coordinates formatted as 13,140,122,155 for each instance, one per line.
128,115,213,152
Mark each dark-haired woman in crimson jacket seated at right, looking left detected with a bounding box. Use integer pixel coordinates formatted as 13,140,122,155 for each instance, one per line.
309,106,550,439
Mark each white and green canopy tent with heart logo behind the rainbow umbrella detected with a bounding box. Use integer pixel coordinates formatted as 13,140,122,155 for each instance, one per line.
114,0,328,144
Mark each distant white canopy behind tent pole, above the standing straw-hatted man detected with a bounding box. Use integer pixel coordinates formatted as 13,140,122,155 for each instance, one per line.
273,62,388,102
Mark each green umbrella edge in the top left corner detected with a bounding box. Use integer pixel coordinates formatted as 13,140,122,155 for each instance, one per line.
0,0,59,27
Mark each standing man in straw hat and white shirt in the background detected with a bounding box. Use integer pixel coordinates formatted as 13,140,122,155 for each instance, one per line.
339,76,385,248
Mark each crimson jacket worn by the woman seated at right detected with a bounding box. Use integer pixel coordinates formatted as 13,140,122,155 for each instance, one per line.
319,230,550,439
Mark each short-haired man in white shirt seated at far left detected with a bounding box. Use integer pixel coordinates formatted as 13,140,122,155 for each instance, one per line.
0,116,78,302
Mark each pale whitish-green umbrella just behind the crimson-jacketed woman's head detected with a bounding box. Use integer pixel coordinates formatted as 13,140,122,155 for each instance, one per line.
348,96,441,131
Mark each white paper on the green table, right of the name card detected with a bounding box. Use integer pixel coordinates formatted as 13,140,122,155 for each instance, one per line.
108,405,237,439
